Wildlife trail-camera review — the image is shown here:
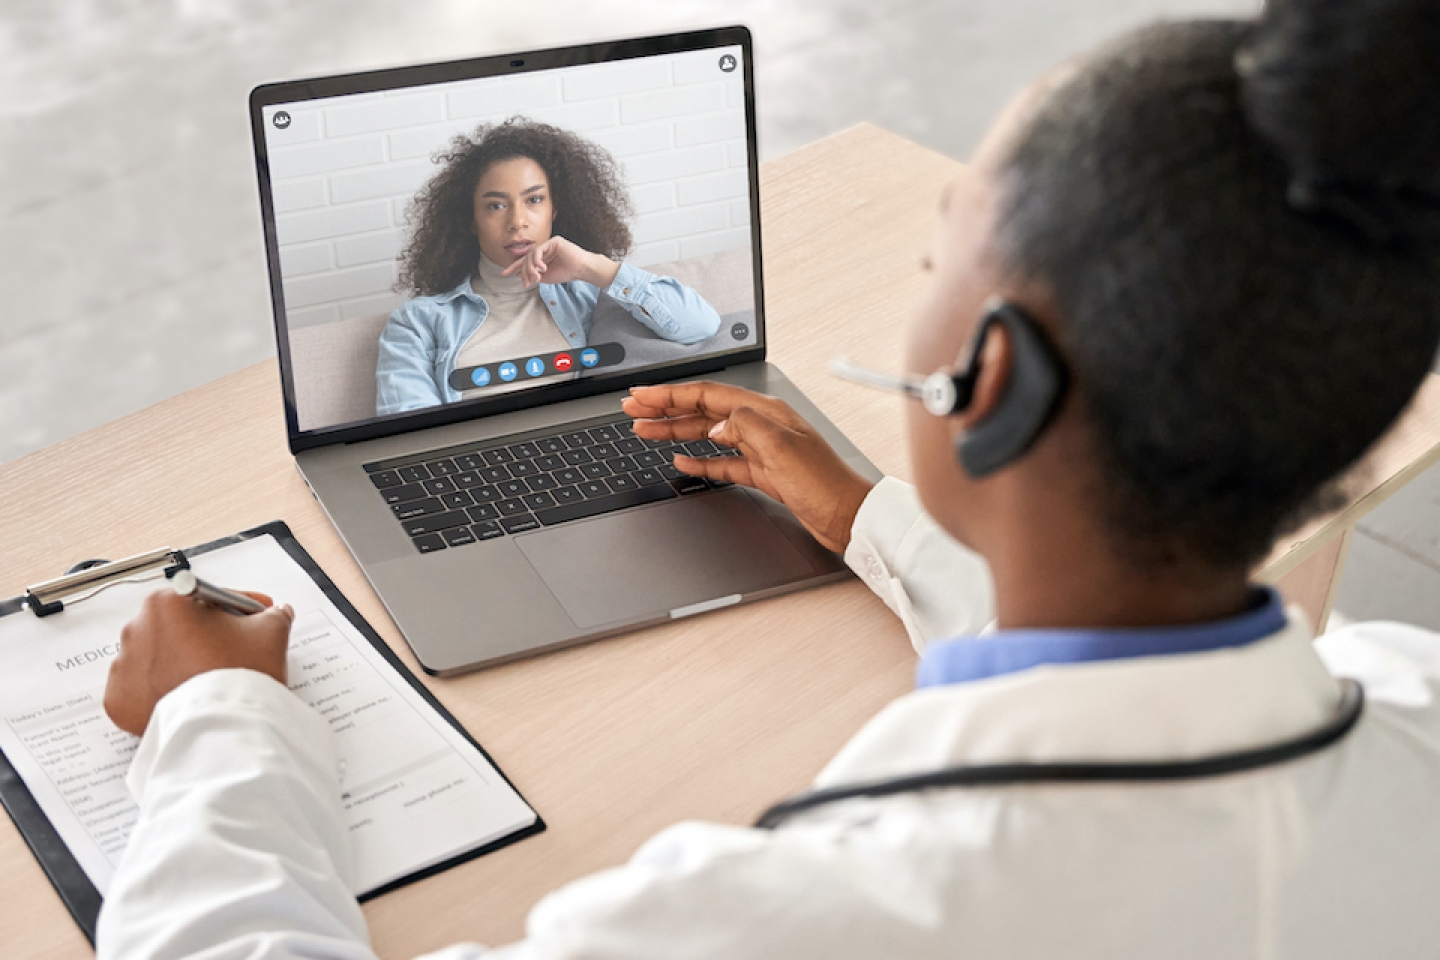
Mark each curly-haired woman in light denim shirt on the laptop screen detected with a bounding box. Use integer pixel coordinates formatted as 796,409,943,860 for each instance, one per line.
376,117,720,415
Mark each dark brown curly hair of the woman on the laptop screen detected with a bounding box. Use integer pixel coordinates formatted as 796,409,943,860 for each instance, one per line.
396,117,631,296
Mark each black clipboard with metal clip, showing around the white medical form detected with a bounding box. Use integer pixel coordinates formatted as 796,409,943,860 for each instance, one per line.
0,520,546,946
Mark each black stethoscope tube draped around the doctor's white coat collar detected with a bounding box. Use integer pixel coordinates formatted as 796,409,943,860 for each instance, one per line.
755,679,1365,830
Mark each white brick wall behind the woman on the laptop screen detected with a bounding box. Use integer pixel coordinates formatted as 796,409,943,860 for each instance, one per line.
265,47,750,327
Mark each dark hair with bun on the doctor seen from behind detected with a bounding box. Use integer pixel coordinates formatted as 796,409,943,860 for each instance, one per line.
996,0,1440,569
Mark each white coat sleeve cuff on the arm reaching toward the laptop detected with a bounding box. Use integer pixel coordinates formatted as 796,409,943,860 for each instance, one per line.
845,476,995,653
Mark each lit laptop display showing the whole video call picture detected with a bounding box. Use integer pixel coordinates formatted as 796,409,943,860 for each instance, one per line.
262,46,757,430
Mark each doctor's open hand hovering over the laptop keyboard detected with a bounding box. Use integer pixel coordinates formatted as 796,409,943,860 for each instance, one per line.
621,381,873,553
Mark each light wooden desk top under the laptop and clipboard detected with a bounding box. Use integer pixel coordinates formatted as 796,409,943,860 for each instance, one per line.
0,125,1440,957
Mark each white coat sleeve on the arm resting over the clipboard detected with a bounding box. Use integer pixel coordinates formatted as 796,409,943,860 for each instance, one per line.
96,669,374,960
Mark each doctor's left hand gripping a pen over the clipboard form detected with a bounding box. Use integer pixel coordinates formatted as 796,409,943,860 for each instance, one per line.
105,590,295,737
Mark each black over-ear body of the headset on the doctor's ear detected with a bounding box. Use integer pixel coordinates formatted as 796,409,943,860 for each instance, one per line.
953,301,1070,478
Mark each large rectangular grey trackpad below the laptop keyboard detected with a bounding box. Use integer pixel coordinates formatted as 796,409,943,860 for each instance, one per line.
516,489,814,629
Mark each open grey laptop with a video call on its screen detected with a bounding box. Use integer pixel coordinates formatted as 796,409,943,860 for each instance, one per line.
251,27,880,675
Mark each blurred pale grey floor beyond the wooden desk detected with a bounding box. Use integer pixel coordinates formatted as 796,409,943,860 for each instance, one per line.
0,0,1440,628
